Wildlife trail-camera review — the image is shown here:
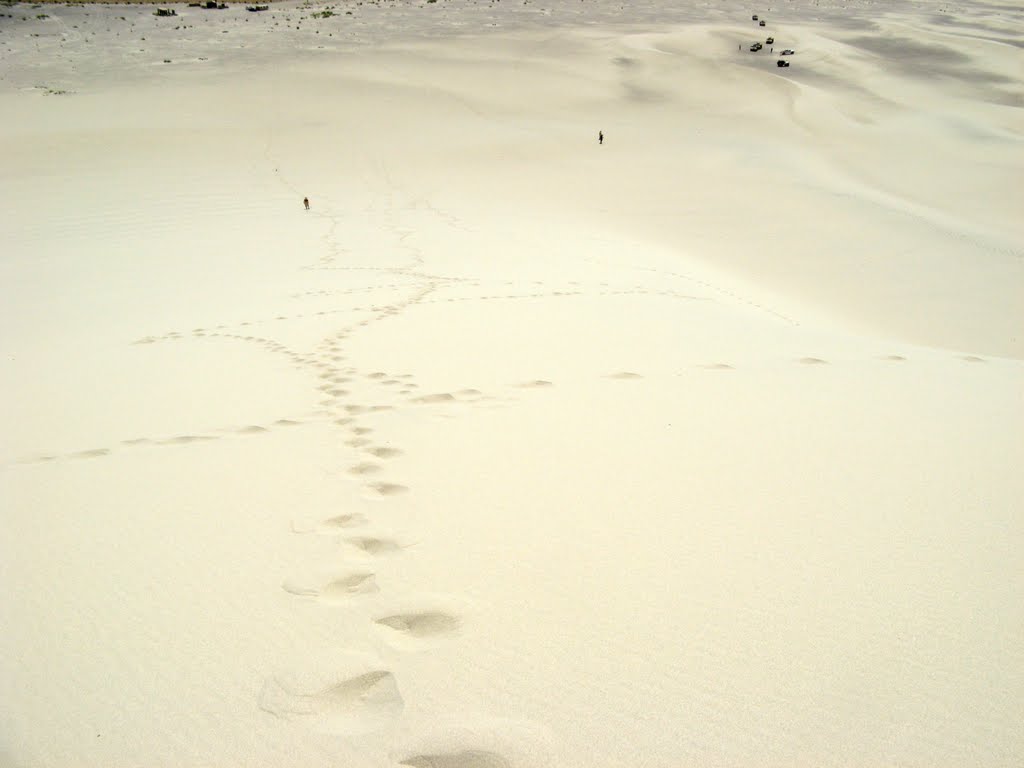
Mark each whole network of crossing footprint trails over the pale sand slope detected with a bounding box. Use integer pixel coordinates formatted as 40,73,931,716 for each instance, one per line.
12,145,984,768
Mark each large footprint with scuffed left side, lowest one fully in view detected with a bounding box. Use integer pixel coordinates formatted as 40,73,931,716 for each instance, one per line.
259,670,402,735
